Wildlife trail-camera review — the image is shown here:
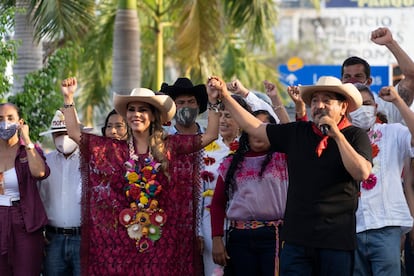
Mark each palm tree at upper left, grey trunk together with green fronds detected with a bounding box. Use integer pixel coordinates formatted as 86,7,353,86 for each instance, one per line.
0,0,95,93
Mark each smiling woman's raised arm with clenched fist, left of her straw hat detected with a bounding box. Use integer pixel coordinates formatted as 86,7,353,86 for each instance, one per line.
61,78,81,144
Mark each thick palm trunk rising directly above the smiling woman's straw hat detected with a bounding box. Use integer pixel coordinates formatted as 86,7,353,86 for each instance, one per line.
112,0,141,95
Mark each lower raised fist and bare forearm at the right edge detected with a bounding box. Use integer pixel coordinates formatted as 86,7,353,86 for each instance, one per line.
378,86,414,146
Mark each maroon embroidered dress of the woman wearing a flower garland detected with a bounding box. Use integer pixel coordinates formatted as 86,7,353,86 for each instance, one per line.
81,134,202,275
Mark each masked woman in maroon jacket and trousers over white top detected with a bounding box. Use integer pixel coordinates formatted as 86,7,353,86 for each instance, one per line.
0,103,50,275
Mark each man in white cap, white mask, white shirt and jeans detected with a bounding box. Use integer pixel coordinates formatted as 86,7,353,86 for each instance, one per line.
39,110,90,275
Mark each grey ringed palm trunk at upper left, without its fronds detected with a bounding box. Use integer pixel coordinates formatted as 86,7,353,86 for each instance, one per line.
12,0,43,94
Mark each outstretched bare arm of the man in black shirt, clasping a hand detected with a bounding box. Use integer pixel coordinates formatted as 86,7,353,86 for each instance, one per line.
207,76,268,141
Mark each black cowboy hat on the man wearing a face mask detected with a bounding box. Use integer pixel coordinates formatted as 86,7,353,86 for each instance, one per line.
160,78,208,114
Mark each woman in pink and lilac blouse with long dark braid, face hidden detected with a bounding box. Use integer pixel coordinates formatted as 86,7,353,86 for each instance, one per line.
211,110,288,275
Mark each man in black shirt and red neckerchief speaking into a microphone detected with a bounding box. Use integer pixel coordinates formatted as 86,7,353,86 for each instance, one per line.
209,77,372,276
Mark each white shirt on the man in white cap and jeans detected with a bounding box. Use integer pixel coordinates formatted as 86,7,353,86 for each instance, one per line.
39,149,82,228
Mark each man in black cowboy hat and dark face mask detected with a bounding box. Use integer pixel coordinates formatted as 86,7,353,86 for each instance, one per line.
160,78,208,134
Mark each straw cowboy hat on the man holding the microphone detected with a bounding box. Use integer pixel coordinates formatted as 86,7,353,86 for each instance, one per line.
299,76,362,112
